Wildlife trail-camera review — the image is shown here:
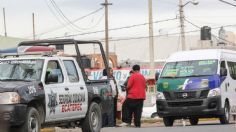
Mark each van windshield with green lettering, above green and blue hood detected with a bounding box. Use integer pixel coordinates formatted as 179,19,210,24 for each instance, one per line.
161,60,218,78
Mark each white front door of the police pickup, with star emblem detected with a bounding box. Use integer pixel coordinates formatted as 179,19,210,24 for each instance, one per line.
43,60,69,122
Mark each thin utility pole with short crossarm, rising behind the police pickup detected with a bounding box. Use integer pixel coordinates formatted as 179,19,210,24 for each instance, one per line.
102,0,112,64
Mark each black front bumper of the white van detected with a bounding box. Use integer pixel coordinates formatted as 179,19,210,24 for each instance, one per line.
156,96,224,119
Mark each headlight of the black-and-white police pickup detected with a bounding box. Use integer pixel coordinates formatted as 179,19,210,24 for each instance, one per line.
0,92,20,104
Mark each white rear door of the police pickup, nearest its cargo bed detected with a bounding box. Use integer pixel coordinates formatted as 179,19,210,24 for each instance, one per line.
62,59,88,118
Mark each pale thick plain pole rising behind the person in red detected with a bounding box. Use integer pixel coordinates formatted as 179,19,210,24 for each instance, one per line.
148,0,155,75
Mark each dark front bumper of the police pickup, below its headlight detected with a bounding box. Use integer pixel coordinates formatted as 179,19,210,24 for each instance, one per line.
0,104,27,126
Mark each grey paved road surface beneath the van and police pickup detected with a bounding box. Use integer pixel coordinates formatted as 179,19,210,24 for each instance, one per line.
53,121,236,132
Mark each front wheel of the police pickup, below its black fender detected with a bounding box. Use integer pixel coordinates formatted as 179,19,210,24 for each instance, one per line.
10,107,41,132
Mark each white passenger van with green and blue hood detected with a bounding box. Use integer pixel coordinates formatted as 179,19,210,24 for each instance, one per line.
156,49,236,126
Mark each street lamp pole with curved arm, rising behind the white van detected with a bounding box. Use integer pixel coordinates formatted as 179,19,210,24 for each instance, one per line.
179,0,199,51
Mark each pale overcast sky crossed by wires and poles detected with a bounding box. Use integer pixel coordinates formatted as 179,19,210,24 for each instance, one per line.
0,0,236,39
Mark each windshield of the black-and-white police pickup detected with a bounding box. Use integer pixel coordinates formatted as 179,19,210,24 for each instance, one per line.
0,59,43,81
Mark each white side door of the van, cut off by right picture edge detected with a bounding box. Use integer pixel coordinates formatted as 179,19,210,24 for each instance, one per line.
226,61,236,114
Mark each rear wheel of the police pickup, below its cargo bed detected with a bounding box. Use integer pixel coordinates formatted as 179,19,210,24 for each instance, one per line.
82,102,102,132
